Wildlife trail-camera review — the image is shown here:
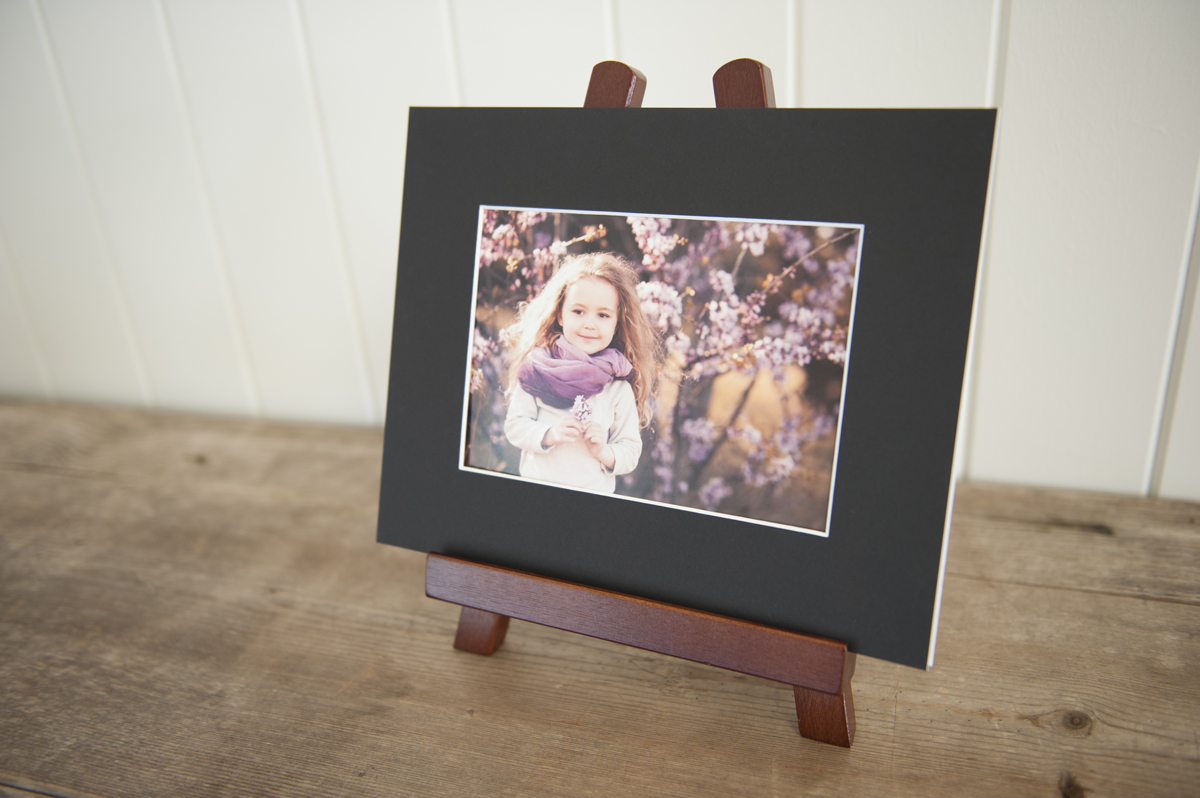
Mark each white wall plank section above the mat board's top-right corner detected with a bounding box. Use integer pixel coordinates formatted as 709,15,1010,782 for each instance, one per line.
798,0,992,108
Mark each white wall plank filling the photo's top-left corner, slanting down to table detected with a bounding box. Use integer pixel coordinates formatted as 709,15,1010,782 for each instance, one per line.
0,0,144,403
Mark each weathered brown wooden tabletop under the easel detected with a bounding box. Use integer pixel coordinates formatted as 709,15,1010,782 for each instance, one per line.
0,402,1200,798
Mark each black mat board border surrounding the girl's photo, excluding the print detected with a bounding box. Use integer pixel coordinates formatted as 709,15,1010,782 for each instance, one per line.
378,108,995,667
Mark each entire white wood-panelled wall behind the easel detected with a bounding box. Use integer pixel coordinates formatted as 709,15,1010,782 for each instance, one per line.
0,0,1200,500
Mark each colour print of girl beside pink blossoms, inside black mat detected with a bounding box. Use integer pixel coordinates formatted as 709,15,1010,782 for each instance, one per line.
460,206,863,536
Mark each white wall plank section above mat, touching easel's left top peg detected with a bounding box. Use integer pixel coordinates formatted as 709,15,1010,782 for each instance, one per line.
445,0,606,106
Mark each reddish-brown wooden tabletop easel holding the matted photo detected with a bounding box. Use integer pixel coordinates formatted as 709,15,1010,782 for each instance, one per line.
425,59,854,748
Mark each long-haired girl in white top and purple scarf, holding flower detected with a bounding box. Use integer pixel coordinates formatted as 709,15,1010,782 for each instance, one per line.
504,252,661,493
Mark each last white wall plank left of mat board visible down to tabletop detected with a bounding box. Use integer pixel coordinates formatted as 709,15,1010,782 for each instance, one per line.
166,0,378,422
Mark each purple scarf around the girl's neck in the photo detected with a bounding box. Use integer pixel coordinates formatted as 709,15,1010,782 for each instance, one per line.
517,336,634,409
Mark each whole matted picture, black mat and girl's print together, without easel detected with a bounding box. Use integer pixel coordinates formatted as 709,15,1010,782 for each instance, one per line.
379,62,995,744
